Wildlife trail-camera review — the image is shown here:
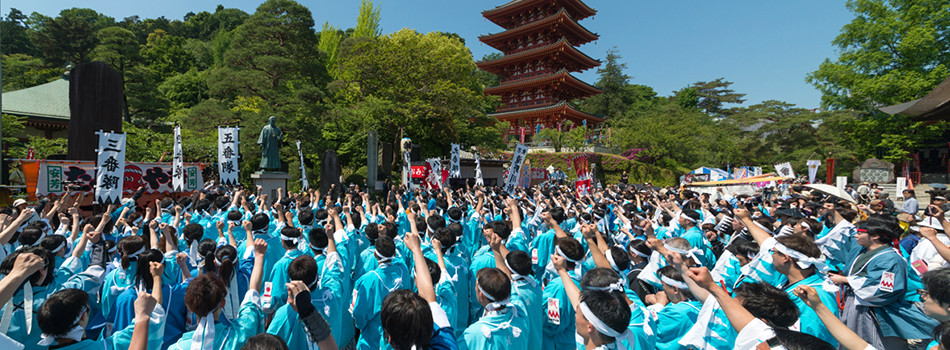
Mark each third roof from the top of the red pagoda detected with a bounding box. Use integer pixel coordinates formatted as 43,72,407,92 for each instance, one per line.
476,39,600,75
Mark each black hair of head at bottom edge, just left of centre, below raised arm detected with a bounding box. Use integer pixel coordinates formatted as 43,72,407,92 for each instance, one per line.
379,289,434,350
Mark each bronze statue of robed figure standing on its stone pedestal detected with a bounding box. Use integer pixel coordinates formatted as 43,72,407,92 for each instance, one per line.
251,116,290,199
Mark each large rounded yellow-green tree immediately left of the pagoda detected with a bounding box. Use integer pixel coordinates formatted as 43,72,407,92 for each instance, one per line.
324,29,501,165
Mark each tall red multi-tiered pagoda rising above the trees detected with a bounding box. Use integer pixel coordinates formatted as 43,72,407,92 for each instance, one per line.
477,0,604,141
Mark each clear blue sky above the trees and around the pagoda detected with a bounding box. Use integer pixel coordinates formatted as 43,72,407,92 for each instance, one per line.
2,0,853,108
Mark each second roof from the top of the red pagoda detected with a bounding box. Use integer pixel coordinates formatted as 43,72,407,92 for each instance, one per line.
478,9,599,52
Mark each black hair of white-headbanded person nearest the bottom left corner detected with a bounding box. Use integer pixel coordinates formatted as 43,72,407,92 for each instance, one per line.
36,288,89,335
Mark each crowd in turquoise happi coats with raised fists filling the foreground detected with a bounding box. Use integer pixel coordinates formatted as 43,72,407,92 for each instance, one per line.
0,179,950,350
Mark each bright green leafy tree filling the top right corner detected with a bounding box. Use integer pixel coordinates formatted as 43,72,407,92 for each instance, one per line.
806,0,950,111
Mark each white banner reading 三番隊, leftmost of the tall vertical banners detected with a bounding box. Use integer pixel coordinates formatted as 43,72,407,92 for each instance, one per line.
96,130,125,204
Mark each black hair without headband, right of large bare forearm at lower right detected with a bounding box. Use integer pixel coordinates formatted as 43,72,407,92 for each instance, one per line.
733,282,799,328
